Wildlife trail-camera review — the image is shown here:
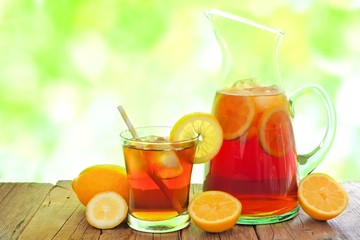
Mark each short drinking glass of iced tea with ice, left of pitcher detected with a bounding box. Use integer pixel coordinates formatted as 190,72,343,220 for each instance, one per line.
120,127,197,233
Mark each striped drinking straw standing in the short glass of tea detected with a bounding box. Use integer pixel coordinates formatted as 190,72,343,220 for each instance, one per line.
117,105,183,214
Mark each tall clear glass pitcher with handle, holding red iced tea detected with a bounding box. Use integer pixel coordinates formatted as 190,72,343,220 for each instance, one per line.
203,10,336,224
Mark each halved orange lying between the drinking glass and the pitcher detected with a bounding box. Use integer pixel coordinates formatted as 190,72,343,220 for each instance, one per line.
188,191,242,233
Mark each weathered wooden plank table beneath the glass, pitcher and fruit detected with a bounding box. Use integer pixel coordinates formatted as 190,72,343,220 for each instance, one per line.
0,181,360,240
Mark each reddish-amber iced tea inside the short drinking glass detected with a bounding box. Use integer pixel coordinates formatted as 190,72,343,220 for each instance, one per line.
123,135,196,221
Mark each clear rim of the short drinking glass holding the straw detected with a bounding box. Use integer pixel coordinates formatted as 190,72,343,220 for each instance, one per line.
120,126,199,146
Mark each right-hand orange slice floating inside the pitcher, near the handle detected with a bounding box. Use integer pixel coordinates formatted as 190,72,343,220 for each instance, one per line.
258,105,295,157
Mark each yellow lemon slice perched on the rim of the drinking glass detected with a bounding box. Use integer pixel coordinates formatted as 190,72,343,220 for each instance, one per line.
170,112,223,163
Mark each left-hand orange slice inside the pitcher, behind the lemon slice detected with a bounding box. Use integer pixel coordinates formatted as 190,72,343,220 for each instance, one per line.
213,93,255,140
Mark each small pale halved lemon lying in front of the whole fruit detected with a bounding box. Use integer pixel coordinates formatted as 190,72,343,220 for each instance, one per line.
85,192,128,229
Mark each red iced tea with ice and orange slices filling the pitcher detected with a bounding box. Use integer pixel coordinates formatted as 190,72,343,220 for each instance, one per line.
204,87,298,217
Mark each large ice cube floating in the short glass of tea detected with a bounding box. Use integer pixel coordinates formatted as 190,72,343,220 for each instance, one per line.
144,150,183,179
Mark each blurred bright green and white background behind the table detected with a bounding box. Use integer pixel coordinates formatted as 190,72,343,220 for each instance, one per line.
0,0,360,182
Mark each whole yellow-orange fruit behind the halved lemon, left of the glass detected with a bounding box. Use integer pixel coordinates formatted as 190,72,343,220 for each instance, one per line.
72,164,129,206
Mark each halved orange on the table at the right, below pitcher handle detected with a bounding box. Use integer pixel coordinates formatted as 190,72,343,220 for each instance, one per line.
298,173,349,221
